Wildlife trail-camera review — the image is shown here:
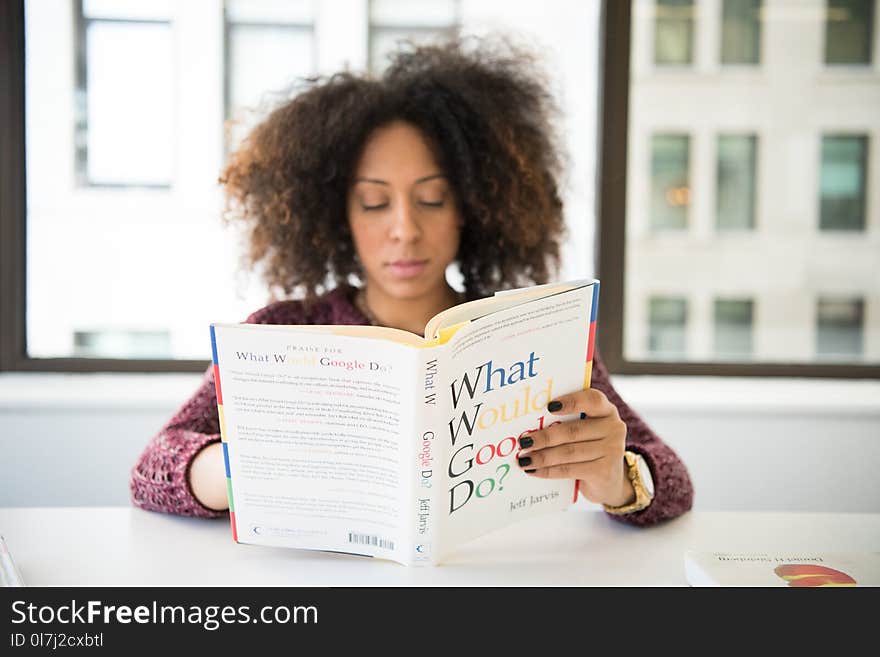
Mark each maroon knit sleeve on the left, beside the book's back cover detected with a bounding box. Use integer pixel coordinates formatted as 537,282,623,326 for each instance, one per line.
130,367,226,518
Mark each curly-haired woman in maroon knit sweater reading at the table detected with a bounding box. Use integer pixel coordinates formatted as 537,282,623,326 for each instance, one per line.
131,37,693,525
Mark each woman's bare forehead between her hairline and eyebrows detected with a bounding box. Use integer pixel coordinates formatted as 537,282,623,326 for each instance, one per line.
356,121,440,181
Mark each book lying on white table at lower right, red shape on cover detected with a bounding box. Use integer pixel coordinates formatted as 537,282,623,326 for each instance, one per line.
685,550,880,588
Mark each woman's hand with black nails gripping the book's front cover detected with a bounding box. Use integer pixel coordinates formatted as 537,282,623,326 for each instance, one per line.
517,389,635,506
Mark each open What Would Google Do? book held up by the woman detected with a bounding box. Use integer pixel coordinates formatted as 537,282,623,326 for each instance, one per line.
211,280,599,565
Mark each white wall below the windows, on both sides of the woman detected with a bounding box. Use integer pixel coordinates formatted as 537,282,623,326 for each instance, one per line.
0,374,880,513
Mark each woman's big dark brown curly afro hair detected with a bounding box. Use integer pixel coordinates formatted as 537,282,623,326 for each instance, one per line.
220,39,564,301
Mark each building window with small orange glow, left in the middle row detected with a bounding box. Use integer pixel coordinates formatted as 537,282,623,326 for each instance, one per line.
651,135,690,230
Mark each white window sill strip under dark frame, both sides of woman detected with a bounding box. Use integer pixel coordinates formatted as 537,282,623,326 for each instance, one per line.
0,373,880,417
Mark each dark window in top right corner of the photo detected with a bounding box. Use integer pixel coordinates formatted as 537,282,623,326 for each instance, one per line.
825,0,876,64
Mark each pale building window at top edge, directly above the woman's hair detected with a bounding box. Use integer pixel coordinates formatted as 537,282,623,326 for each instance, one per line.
369,0,460,74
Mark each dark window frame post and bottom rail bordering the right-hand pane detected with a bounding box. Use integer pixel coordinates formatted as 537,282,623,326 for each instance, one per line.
594,0,880,379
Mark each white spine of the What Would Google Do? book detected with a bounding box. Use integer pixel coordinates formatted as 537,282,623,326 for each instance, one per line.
411,347,443,566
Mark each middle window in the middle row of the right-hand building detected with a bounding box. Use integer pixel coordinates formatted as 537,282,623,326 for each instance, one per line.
716,135,757,230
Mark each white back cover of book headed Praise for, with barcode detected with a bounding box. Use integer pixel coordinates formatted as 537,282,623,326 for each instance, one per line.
212,324,420,561
